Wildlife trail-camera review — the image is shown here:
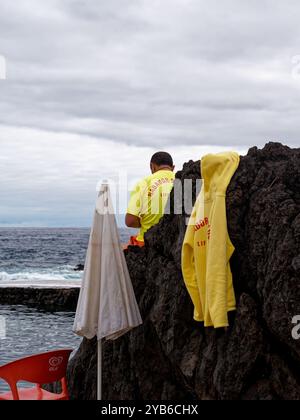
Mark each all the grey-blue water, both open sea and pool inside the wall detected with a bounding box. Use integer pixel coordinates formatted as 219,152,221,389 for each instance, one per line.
0,228,137,392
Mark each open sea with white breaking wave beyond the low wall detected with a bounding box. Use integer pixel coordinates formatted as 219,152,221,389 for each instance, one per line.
0,228,132,286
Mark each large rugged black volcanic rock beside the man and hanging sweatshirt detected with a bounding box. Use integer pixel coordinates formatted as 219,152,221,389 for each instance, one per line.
69,143,300,400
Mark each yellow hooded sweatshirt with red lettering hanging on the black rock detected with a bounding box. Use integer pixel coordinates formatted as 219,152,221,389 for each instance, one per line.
182,152,240,328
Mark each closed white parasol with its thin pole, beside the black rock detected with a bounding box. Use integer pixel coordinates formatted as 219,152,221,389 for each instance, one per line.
73,184,142,400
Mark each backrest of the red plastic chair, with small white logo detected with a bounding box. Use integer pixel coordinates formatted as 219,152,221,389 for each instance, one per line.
0,349,73,385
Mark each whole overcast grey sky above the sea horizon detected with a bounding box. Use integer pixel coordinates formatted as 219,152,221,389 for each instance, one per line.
0,0,300,226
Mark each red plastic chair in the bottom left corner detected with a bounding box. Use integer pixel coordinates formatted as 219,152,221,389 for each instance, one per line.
0,349,73,401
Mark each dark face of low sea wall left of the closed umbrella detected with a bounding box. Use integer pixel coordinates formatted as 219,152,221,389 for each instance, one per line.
0,287,80,312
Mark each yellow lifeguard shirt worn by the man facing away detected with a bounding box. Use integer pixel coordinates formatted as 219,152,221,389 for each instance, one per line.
127,170,175,242
